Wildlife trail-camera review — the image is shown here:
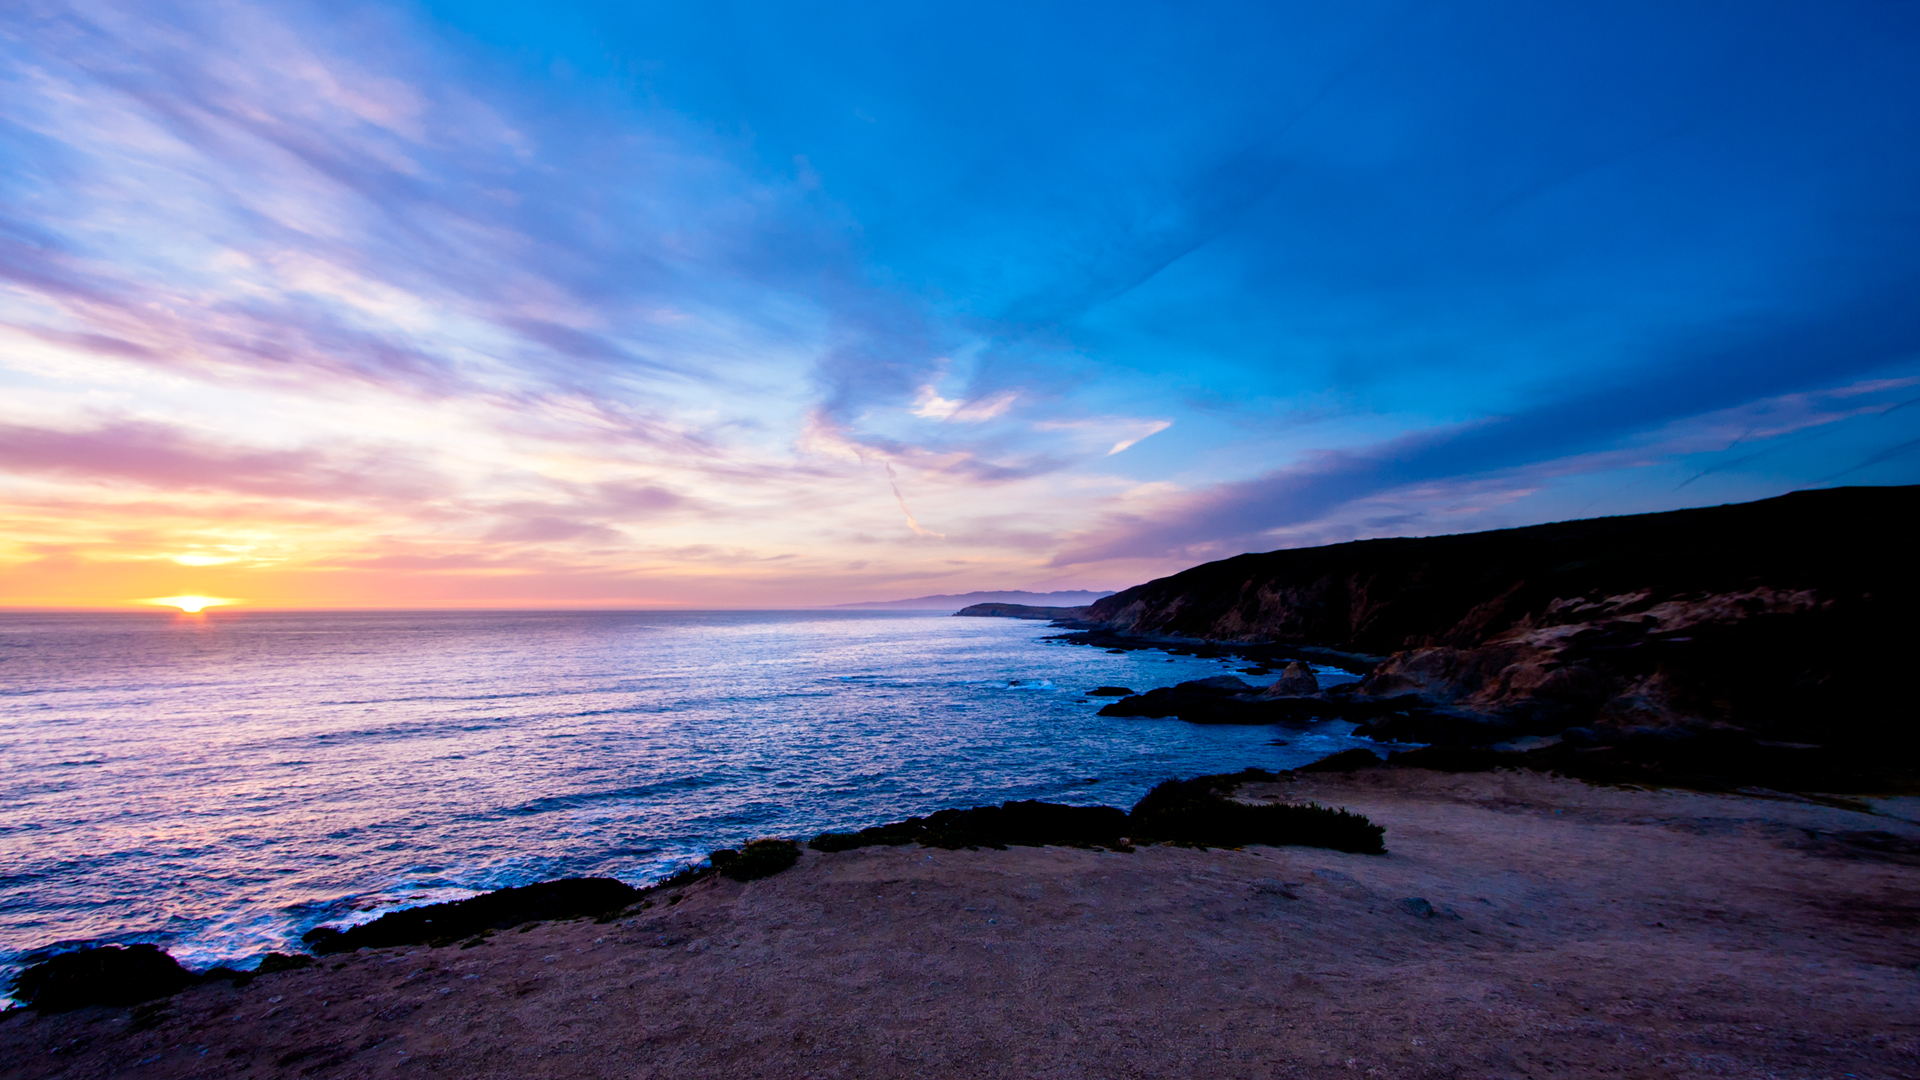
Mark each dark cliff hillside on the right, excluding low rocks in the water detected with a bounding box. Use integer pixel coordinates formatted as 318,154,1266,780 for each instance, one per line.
1077,486,1920,744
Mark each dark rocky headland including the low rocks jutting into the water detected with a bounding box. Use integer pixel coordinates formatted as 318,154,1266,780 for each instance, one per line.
975,486,1920,792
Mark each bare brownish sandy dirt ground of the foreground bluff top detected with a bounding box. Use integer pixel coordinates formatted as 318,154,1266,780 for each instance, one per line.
11,771,1920,1080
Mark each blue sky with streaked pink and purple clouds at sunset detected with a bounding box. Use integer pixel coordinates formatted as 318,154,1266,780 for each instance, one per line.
0,0,1920,607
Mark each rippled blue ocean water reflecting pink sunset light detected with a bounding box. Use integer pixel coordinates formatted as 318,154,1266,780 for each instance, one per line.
0,611,1359,974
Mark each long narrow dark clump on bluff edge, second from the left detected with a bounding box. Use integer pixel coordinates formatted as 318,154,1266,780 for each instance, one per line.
301,878,641,955
